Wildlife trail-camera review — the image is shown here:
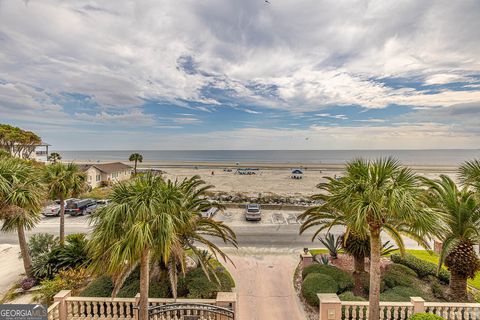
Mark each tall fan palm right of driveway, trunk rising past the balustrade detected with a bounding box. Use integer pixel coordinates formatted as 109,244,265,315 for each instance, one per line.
306,158,438,320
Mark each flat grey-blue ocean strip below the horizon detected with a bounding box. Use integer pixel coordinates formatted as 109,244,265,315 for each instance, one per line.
54,149,480,166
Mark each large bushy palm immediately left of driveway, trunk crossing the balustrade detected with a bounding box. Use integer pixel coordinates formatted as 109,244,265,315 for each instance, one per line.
90,174,236,319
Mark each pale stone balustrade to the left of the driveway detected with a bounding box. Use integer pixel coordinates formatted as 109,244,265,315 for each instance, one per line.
48,290,237,320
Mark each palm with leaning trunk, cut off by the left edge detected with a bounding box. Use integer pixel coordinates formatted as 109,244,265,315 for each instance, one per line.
0,158,43,275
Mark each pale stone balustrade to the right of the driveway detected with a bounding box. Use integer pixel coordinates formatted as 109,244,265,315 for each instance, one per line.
318,294,480,320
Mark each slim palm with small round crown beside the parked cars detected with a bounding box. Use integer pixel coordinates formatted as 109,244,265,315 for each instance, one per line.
42,162,87,246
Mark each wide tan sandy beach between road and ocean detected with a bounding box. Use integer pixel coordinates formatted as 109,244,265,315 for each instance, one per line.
76,161,457,197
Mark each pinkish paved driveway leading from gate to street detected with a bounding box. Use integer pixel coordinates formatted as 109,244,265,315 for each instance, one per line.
223,248,306,320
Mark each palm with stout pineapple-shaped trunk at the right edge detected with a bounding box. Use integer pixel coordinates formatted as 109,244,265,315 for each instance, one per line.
423,175,480,301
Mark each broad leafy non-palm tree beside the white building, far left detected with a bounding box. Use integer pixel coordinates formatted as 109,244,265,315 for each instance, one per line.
0,124,42,159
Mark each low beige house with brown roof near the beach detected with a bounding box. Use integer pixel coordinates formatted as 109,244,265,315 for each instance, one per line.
80,162,132,188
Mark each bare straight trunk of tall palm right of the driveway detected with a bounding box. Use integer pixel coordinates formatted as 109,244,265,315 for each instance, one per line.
368,227,382,320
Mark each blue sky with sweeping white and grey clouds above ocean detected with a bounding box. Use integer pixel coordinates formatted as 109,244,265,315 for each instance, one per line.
0,0,480,150
